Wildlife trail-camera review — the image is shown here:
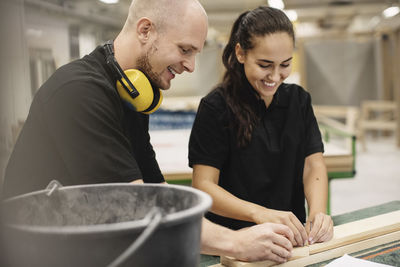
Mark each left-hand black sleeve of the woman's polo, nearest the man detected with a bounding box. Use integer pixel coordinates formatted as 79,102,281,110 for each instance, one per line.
189,100,229,169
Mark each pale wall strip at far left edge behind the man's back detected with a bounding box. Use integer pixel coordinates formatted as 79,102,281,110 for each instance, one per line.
0,0,31,189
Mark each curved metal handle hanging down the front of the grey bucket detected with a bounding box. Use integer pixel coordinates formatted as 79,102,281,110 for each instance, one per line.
107,207,162,267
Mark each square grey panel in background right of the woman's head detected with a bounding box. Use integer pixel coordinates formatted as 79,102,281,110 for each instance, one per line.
304,38,380,106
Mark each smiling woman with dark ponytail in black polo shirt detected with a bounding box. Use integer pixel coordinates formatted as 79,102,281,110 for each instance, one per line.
189,6,333,249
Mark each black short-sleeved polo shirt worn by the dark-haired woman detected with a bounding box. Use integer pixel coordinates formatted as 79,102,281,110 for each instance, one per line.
189,84,324,229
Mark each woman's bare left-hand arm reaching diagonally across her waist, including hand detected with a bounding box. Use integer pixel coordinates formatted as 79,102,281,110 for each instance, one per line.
193,164,307,246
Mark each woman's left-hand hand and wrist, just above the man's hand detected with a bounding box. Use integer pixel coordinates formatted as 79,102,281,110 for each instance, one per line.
254,208,307,247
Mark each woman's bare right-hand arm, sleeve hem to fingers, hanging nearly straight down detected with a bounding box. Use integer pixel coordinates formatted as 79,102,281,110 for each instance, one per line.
303,152,333,244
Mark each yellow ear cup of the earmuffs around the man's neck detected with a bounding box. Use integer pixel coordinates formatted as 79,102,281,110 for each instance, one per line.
117,69,162,114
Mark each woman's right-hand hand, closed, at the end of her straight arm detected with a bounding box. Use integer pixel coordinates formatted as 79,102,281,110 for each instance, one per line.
306,212,333,245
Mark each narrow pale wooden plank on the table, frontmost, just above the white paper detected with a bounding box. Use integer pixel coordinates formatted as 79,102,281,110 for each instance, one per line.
219,231,400,267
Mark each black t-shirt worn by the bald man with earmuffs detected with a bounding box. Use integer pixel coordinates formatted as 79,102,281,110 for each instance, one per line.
3,46,164,197
